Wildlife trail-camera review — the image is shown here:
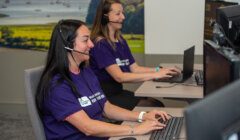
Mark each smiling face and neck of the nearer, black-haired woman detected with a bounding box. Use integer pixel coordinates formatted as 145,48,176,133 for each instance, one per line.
73,25,93,63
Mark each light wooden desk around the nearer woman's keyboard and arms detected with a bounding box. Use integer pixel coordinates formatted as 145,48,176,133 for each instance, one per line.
110,107,186,140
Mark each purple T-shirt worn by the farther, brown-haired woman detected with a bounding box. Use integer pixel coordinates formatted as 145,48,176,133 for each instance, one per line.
90,38,135,81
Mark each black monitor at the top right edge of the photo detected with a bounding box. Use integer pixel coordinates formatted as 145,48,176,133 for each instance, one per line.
216,5,240,53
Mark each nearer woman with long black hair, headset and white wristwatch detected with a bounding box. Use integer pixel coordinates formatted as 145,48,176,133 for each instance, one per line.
36,20,169,140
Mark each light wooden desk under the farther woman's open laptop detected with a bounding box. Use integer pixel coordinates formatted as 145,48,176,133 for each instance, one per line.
135,64,203,99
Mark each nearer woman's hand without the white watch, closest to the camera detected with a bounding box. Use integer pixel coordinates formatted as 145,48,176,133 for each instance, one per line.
133,120,166,135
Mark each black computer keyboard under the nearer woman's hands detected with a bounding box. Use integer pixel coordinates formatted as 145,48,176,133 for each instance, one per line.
150,117,183,140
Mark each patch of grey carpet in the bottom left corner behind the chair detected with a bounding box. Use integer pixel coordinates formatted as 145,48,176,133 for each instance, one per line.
0,113,35,140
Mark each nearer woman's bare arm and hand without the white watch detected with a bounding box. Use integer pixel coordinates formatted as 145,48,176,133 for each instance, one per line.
65,110,165,137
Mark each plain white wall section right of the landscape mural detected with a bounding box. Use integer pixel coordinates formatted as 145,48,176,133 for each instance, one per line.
144,0,205,54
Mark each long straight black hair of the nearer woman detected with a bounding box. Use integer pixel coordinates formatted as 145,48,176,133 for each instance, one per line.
36,19,86,115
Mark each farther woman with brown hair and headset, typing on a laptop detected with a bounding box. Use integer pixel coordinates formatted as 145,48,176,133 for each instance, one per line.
90,0,180,110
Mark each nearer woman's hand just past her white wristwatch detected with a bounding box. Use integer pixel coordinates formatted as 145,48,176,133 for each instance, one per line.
143,110,170,121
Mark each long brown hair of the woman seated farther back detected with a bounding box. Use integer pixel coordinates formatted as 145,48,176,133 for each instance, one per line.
91,0,122,47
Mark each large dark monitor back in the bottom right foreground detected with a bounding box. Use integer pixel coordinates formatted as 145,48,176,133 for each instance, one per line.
184,80,240,140
